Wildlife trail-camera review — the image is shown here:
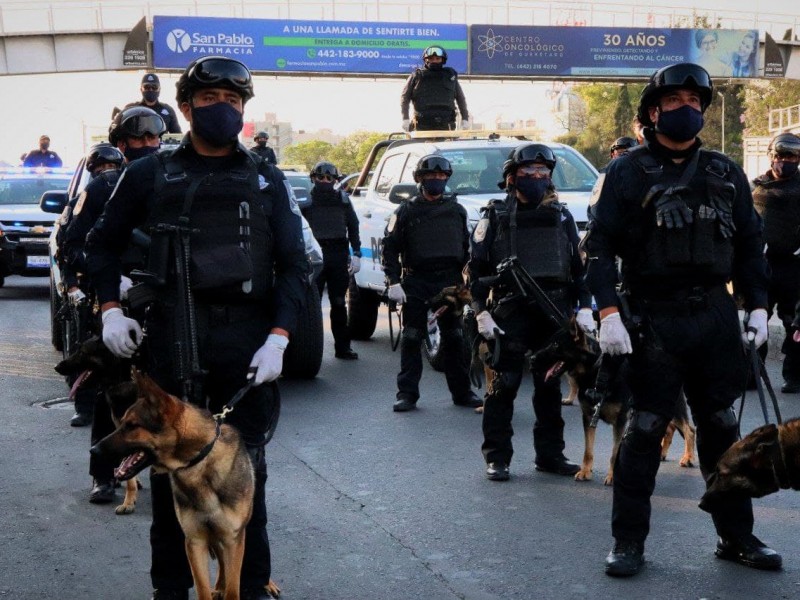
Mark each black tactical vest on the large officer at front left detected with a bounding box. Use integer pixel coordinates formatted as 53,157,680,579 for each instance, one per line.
146,151,275,303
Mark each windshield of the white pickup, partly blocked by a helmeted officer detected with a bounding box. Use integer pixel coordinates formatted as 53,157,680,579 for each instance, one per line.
441,146,597,194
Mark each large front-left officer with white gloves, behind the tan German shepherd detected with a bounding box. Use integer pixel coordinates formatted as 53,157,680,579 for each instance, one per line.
87,56,307,600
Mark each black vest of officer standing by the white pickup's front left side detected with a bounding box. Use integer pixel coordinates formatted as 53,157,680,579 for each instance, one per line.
403,197,466,270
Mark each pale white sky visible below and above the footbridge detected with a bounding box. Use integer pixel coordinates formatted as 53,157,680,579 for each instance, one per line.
0,0,800,165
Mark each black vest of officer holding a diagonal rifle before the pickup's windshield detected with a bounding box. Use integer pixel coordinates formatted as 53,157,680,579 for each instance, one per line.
492,197,572,283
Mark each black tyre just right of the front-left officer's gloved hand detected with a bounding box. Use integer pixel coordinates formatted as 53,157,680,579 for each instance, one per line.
282,284,324,379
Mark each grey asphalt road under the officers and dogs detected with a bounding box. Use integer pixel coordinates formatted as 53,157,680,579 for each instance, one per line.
0,277,800,600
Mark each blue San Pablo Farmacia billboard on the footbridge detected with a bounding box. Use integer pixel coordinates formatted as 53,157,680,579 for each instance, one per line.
153,16,467,74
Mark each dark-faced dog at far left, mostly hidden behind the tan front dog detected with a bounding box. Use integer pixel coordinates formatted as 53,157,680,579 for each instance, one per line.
55,336,141,515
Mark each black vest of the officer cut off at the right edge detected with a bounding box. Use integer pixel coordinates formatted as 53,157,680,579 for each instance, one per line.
753,174,800,255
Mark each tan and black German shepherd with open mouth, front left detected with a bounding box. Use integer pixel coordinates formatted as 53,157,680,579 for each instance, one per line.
91,369,280,600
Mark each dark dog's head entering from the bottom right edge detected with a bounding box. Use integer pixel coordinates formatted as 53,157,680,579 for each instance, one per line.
700,419,800,512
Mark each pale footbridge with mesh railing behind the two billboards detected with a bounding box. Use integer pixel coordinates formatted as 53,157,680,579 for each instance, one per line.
0,0,800,79
